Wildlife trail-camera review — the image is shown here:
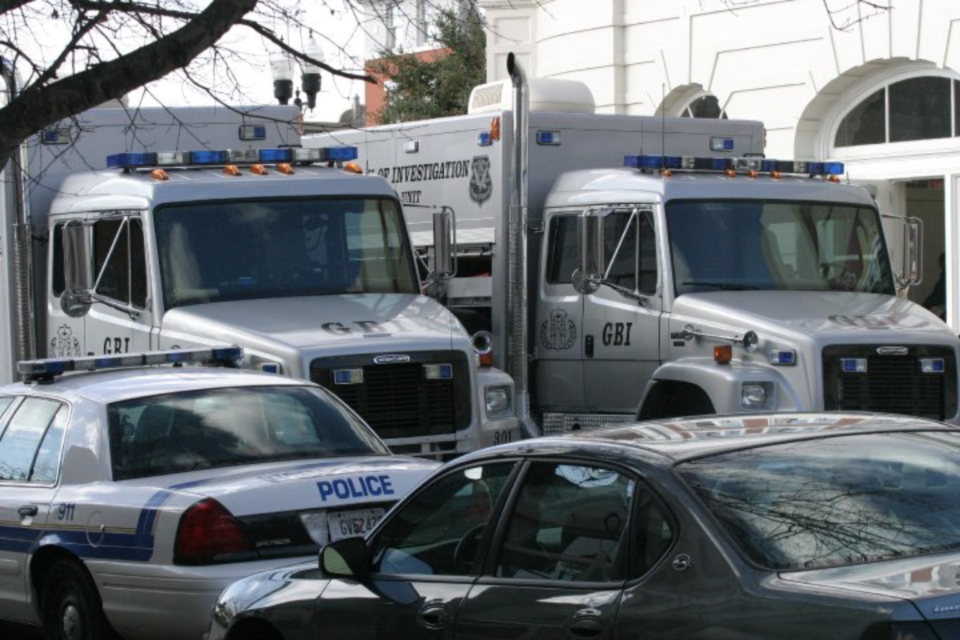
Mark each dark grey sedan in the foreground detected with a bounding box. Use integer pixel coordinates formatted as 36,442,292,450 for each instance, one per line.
210,414,960,640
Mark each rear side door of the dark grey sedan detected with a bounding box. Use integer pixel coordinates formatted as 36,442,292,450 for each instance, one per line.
455,461,637,640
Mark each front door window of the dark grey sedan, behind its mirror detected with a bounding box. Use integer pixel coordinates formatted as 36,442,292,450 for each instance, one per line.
373,462,514,576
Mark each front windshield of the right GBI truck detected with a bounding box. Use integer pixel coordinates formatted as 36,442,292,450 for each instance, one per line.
666,200,895,295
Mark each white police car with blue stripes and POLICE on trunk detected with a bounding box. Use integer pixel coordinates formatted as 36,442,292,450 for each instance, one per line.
0,347,437,640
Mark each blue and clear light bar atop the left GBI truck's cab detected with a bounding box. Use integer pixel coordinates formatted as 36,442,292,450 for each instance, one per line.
107,146,359,171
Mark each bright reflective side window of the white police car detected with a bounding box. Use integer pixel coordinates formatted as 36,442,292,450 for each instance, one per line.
0,398,63,482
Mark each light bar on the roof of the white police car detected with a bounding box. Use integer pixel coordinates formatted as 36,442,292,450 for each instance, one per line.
17,345,243,382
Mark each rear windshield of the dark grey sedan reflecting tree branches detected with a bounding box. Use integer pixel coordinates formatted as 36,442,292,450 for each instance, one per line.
679,431,960,570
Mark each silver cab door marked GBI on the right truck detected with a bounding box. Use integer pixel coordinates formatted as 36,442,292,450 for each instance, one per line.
583,208,661,413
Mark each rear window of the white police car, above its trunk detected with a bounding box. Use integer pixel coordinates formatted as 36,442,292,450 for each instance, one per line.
109,386,389,480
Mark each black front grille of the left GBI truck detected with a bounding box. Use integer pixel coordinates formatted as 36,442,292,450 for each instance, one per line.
310,351,470,439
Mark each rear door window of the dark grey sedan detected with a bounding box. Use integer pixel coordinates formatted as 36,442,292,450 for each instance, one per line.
496,463,636,582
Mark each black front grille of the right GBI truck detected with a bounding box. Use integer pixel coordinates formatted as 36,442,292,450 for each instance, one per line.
823,345,957,420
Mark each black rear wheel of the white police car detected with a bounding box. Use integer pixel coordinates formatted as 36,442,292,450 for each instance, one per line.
40,560,115,640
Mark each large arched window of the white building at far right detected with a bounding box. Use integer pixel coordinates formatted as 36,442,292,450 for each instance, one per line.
834,76,960,147
